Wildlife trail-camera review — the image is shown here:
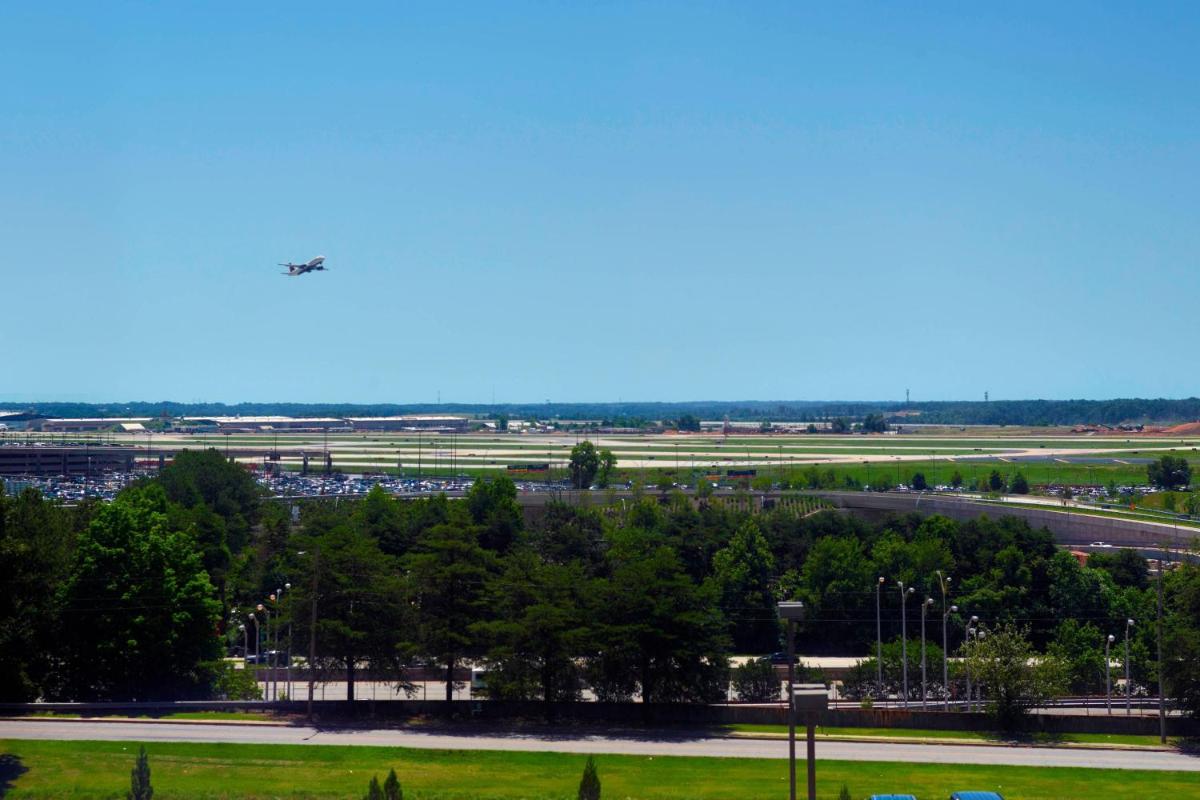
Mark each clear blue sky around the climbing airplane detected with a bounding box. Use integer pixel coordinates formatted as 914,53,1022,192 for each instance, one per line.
0,2,1200,402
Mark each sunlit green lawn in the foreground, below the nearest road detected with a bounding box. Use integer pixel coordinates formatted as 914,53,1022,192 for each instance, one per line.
0,741,1200,800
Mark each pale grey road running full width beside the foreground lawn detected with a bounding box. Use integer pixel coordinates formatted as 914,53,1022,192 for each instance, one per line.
0,720,1200,772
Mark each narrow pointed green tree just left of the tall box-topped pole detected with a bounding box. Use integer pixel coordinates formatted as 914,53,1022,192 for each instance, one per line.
713,519,779,652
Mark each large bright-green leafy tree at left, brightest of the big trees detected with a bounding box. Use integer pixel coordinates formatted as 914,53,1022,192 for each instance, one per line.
56,485,221,700
